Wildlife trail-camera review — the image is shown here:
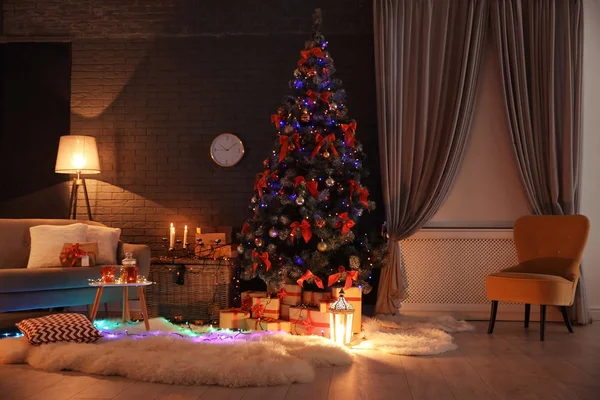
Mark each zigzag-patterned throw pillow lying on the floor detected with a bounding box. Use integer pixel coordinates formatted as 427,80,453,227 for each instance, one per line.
17,314,102,345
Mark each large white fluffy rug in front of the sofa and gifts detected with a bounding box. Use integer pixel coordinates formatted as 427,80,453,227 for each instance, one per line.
0,321,353,387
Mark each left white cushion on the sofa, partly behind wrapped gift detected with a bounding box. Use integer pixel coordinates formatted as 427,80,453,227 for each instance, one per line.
27,224,88,268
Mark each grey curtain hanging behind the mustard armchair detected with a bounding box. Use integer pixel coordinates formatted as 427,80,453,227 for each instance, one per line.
491,0,589,323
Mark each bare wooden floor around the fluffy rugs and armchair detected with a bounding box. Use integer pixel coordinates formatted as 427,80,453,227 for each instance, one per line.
0,321,600,400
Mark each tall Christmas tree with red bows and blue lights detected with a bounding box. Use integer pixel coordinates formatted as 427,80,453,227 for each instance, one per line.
238,10,384,293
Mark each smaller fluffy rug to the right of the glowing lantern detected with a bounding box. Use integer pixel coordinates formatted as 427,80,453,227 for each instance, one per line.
354,316,475,356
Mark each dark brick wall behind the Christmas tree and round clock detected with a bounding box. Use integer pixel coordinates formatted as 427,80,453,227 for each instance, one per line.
3,0,381,252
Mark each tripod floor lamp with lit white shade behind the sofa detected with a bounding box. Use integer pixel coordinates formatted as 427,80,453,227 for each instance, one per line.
54,135,100,221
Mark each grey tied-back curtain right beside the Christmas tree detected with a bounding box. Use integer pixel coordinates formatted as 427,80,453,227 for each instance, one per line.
373,0,489,314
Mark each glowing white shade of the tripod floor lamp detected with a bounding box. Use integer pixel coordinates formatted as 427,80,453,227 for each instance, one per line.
54,135,100,174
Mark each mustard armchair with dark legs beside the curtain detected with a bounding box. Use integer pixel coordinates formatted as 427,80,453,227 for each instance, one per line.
485,215,590,341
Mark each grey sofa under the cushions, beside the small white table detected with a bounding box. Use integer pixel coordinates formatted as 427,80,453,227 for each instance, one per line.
0,219,150,312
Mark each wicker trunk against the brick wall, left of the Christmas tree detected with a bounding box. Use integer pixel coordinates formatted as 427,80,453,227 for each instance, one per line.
146,260,233,321
